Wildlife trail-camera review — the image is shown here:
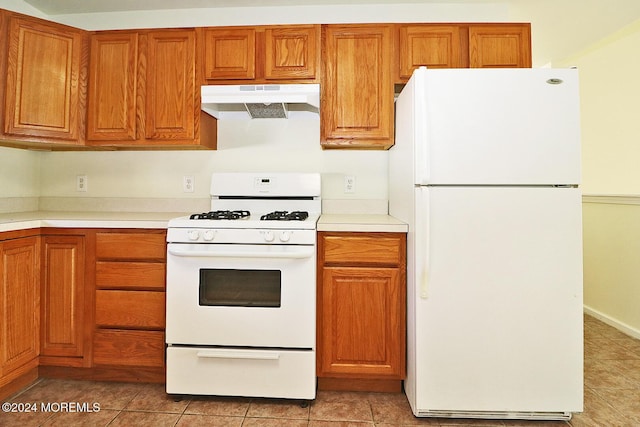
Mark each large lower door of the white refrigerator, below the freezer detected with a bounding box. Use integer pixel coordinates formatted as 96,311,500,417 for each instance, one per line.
407,187,583,419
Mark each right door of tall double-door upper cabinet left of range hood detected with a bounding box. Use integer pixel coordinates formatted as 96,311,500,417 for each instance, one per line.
145,30,195,140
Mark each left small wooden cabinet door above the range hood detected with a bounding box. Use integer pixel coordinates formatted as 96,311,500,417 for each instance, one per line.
204,28,256,80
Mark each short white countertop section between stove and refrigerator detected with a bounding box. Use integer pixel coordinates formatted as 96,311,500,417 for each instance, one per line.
318,214,409,233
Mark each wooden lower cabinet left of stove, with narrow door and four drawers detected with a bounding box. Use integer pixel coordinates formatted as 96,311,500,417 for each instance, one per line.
39,229,166,382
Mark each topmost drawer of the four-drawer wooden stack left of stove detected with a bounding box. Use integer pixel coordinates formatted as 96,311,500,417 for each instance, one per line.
96,232,166,260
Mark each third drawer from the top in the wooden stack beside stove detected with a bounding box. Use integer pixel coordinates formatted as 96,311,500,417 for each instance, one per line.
96,290,165,329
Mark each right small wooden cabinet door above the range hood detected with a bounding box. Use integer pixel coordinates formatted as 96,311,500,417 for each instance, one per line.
264,25,320,80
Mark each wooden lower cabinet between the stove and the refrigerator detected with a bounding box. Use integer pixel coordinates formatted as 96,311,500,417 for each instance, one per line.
317,232,406,391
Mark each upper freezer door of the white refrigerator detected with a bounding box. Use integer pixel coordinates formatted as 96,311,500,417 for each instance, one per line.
410,68,580,185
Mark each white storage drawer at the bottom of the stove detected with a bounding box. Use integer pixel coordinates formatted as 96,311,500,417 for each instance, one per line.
166,346,316,400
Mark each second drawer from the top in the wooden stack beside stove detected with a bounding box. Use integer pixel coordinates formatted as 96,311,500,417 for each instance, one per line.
96,261,165,290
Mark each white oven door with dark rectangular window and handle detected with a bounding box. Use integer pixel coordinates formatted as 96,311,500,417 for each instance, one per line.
166,243,316,349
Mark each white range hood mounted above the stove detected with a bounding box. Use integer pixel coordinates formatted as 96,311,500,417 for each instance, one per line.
201,83,320,119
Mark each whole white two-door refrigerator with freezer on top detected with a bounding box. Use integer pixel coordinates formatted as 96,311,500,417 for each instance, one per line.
389,67,583,419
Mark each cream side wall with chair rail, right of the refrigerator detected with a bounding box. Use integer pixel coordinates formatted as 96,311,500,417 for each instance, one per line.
563,21,640,337
